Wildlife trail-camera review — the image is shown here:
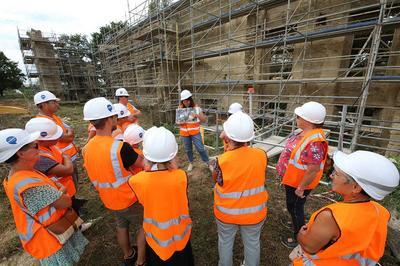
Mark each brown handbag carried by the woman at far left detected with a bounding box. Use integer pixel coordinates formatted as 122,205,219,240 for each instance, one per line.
45,208,83,244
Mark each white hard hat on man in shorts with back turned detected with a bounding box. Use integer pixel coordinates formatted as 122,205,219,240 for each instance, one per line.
83,97,117,120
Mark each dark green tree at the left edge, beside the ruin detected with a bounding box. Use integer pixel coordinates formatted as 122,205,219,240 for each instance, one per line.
0,51,25,96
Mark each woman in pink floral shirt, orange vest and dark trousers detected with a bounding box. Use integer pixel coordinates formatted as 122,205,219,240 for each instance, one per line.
276,102,328,248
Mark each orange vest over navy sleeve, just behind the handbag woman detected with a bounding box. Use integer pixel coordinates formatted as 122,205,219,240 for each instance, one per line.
39,145,76,197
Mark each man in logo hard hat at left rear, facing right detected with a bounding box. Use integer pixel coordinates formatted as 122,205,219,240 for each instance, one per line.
33,91,78,188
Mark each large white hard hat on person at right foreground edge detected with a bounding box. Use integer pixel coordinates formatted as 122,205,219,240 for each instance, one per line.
333,151,399,200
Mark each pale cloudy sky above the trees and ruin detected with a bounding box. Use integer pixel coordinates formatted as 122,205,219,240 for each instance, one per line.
0,0,144,72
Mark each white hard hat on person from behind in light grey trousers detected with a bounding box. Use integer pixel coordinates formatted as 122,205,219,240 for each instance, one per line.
223,111,254,142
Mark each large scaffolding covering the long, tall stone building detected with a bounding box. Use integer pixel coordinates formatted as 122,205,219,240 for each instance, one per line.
98,0,400,154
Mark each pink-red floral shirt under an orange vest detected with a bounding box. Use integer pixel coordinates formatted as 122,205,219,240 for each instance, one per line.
276,132,328,176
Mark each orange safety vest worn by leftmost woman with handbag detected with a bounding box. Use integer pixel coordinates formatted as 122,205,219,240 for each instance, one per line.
3,171,66,259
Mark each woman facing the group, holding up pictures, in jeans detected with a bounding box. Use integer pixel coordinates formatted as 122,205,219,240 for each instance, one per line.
178,90,212,172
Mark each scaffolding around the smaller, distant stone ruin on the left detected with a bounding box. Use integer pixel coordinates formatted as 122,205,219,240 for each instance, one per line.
18,29,99,101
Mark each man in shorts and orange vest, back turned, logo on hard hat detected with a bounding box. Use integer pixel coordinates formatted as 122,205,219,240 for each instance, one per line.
83,97,146,265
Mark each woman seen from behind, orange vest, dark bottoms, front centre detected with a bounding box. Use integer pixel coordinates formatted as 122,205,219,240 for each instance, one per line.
129,127,194,266
